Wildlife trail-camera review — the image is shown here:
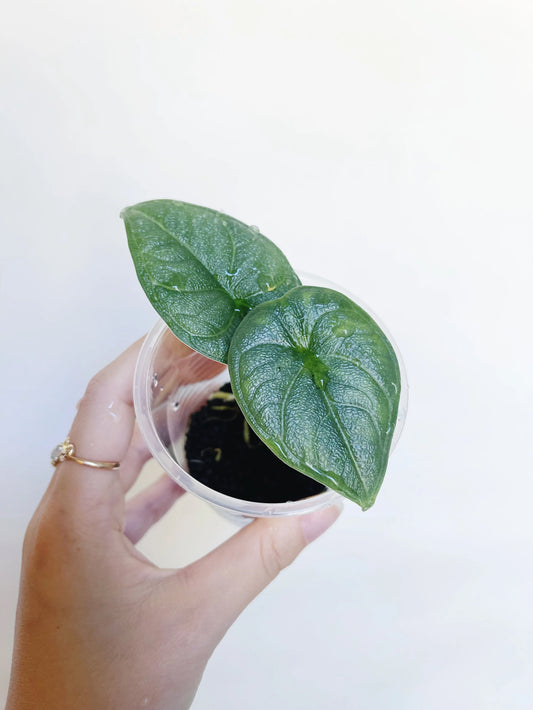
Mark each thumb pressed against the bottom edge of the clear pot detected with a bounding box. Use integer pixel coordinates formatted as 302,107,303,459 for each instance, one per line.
183,504,342,643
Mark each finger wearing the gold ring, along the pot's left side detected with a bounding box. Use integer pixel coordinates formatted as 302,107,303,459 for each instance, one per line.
50,340,142,527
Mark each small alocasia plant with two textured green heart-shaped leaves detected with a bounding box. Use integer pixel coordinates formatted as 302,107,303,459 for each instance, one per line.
122,200,401,510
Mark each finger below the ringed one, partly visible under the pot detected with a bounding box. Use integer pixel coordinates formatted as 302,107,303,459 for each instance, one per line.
124,474,184,544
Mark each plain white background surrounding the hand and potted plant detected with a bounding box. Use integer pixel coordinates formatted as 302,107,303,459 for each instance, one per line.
0,0,533,710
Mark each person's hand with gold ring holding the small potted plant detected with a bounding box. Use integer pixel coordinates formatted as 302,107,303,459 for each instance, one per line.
7,343,339,710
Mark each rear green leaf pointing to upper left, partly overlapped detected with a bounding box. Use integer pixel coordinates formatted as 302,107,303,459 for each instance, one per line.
121,200,300,362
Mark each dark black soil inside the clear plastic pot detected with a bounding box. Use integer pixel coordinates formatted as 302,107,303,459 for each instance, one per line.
185,383,325,503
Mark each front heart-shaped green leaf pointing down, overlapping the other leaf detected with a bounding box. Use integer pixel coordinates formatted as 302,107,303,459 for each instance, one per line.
229,286,400,510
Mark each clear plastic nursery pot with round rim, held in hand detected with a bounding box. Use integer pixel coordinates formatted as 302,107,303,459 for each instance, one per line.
133,274,407,520
